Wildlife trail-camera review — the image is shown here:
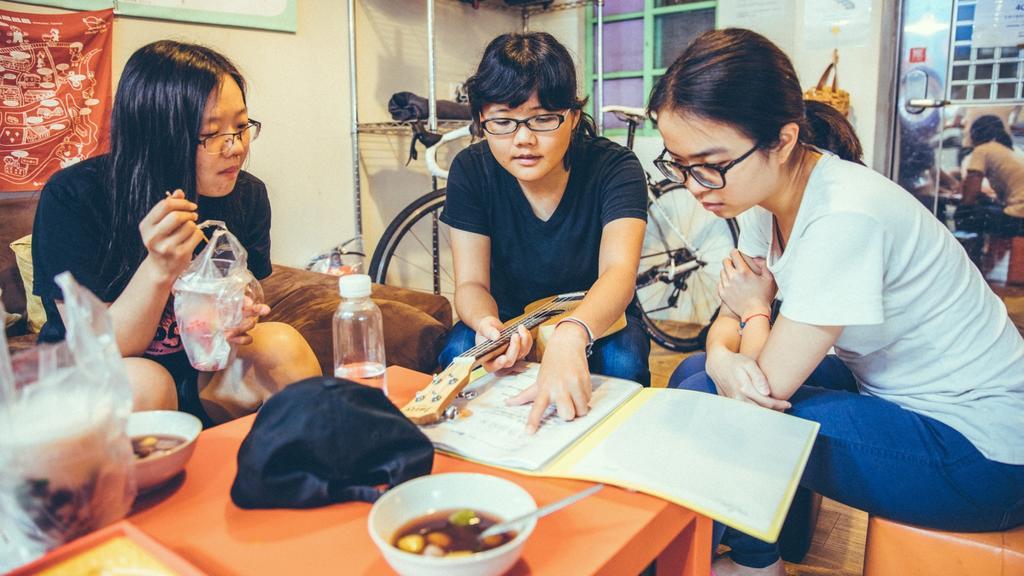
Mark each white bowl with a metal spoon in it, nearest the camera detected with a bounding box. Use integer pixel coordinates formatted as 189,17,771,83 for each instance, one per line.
369,474,537,576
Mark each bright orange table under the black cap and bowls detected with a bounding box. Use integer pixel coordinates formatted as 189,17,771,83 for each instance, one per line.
129,367,712,576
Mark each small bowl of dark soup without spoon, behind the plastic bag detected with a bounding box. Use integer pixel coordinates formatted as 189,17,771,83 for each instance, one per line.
128,410,203,492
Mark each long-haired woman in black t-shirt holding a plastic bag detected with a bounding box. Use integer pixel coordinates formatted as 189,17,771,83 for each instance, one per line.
33,40,319,423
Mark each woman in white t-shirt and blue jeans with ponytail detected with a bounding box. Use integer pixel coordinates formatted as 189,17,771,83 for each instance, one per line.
648,29,1024,576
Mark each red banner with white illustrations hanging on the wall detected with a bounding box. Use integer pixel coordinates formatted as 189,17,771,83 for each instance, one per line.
0,10,114,192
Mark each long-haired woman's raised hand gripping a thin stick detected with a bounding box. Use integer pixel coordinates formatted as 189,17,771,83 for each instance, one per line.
138,190,203,284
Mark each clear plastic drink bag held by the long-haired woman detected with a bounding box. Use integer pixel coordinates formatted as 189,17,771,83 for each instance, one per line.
173,220,263,372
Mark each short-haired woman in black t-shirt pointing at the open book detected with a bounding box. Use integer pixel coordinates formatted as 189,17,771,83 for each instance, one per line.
439,33,650,430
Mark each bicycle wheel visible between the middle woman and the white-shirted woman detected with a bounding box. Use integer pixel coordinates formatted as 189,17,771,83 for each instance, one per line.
637,180,739,352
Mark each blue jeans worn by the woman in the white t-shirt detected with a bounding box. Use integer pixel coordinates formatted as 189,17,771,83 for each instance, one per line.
669,354,1024,568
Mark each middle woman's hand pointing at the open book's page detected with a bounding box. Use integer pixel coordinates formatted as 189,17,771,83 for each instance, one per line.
508,322,593,434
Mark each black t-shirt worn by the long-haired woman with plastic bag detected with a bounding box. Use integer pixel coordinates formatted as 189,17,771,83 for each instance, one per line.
32,156,271,364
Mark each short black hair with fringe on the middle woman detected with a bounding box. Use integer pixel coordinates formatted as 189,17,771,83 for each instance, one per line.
466,32,597,169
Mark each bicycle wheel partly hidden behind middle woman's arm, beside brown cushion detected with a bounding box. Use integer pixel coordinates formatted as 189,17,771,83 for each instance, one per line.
369,189,455,302
